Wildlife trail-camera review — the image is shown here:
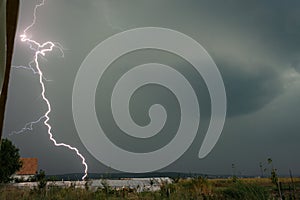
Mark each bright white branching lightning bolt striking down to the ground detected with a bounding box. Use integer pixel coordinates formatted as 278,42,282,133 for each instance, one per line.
14,0,88,180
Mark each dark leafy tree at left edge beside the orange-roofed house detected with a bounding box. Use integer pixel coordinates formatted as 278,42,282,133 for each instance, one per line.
0,139,22,183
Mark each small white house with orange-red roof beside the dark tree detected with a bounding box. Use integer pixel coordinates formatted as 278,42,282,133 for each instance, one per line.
13,158,38,180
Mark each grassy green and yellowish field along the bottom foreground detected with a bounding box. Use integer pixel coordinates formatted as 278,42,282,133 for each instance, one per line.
0,177,300,200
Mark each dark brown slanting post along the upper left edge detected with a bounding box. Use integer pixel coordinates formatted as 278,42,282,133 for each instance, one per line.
0,0,19,139
